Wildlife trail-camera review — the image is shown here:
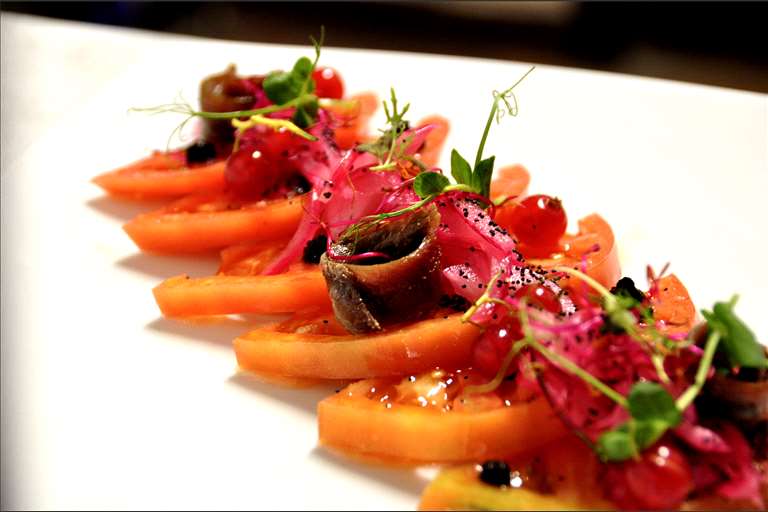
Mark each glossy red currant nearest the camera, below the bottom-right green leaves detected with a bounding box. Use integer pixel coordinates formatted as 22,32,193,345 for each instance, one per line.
613,442,694,510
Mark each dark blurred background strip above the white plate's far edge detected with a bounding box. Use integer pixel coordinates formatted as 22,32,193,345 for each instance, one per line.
6,1,768,92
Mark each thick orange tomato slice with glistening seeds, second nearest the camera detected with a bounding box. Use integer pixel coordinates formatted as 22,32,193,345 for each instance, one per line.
318,370,565,463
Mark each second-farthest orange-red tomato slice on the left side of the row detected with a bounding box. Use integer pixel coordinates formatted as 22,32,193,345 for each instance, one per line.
123,193,303,253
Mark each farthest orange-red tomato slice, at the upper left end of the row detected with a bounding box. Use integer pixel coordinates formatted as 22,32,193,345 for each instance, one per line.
92,151,226,199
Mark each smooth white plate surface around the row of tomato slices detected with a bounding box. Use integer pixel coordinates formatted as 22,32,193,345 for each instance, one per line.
0,13,768,509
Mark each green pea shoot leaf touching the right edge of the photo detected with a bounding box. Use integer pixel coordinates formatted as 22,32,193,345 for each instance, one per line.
702,300,768,368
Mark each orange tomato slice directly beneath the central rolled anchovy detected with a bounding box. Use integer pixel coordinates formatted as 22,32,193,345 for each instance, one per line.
234,312,479,380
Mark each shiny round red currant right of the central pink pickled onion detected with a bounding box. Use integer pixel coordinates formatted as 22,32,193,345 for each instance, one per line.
509,194,568,249
